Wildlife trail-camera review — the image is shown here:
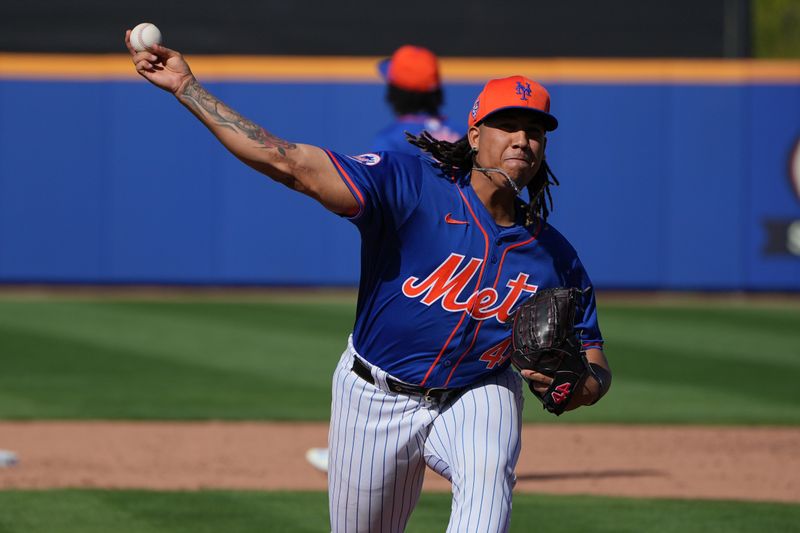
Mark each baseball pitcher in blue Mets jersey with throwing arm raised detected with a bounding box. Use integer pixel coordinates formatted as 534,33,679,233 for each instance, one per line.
126,33,611,532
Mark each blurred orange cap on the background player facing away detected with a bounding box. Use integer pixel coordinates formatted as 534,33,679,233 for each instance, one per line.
378,44,441,93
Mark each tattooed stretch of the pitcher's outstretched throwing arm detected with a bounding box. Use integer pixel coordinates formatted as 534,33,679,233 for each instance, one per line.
179,80,297,156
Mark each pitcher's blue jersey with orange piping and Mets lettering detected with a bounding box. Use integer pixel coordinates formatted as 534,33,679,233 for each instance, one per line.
328,152,603,387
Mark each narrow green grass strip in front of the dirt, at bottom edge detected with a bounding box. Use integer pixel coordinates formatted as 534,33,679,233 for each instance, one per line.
0,490,800,533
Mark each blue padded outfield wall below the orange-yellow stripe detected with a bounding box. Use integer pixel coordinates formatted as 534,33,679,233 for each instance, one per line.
0,75,800,290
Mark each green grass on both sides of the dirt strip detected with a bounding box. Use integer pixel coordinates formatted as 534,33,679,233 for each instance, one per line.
0,294,800,533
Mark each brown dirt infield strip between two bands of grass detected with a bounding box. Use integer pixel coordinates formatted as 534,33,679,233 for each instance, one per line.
0,422,800,503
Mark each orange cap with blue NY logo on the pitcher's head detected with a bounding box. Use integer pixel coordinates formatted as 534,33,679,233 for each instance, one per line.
467,76,558,131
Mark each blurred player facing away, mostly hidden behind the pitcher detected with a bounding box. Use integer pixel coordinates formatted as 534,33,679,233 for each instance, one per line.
306,44,462,472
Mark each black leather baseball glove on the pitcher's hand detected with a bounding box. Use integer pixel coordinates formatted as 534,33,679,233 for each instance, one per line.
507,287,593,416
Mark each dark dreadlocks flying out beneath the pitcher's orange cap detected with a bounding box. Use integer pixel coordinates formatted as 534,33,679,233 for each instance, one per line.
406,131,559,225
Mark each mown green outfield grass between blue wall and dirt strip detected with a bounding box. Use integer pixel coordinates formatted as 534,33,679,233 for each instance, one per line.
0,297,800,425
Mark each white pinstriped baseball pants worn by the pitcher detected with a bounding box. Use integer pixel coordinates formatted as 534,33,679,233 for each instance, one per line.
328,338,523,533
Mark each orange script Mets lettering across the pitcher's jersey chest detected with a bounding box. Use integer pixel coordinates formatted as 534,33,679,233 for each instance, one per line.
403,253,538,323
